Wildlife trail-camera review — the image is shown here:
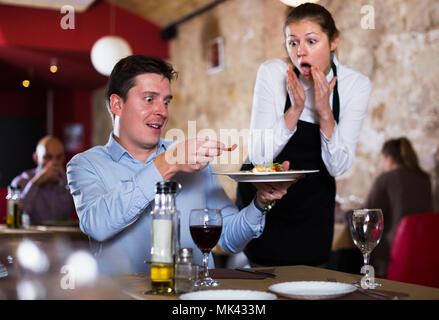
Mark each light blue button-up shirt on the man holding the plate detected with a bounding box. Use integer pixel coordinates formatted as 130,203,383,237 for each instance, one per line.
67,134,265,274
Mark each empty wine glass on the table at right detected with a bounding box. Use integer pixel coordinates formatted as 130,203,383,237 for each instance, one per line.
348,209,384,289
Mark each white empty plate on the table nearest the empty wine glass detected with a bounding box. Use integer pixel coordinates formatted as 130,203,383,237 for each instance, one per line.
268,281,357,300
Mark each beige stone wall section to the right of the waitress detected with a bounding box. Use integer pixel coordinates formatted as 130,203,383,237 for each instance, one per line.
324,0,439,210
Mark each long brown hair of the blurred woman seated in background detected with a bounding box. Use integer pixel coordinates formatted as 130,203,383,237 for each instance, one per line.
381,137,428,175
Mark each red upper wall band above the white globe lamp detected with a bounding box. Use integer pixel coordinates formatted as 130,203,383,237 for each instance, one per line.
0,1,168,58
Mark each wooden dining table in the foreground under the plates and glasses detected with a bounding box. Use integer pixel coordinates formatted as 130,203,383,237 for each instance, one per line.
0,266,439,306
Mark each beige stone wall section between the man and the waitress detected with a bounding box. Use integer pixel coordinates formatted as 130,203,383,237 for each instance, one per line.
168,0,265,199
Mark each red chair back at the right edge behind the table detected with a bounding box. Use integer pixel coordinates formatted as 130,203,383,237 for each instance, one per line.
387,212,439,288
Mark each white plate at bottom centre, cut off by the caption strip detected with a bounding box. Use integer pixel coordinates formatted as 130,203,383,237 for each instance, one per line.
180,290,277,300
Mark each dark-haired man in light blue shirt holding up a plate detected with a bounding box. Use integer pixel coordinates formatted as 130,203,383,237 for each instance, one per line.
67,55,291,274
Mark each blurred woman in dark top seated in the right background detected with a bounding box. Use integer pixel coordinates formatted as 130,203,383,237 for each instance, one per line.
364,137,433,277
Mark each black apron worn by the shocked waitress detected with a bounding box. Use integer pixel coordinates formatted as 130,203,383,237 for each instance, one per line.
237,63,340,266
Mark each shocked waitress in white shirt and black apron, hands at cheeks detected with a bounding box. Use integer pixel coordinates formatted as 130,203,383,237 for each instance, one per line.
237,3,371,266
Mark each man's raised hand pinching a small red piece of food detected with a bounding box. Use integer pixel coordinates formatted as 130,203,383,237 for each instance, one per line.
154,139,236,180
